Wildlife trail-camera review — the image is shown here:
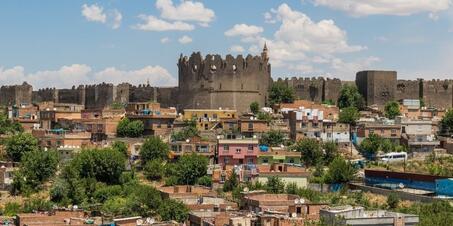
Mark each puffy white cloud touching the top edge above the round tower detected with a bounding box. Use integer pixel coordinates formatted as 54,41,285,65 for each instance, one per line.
156,0,215,25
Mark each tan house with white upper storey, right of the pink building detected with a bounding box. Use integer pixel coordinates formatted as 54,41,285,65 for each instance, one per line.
288,109,324,140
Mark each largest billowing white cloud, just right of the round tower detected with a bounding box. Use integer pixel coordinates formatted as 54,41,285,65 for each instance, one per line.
225,4,377,78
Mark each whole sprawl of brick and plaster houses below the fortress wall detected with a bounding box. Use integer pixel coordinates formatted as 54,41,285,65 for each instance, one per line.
0,96,453,226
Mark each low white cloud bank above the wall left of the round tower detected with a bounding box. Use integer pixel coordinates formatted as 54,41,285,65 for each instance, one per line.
0,64,177,89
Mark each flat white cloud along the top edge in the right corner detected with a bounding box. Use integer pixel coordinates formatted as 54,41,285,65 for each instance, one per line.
314,0,452,16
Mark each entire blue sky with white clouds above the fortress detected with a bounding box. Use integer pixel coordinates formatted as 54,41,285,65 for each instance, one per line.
0,0,453,88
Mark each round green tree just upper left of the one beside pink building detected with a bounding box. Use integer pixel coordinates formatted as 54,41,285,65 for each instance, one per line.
140,137,169,165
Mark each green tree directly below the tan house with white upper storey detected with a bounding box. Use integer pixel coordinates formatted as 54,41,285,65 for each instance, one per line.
294,138,323,166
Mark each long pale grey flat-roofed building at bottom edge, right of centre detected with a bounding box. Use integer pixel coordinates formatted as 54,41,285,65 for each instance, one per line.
320,206,419,226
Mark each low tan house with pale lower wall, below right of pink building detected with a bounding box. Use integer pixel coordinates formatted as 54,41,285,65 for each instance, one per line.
256,163,310,188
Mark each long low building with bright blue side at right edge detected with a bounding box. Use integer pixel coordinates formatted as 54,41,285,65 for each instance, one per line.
364,169,448,195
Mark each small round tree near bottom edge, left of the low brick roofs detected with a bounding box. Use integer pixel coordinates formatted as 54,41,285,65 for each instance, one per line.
157,199,189,223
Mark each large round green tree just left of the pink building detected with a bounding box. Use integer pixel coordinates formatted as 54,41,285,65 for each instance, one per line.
176,153,208,184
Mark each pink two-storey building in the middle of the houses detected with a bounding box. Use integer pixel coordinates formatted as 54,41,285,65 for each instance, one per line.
217,139,259,165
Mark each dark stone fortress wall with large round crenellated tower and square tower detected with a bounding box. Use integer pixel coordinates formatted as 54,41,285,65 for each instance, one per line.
0,50,453,113
